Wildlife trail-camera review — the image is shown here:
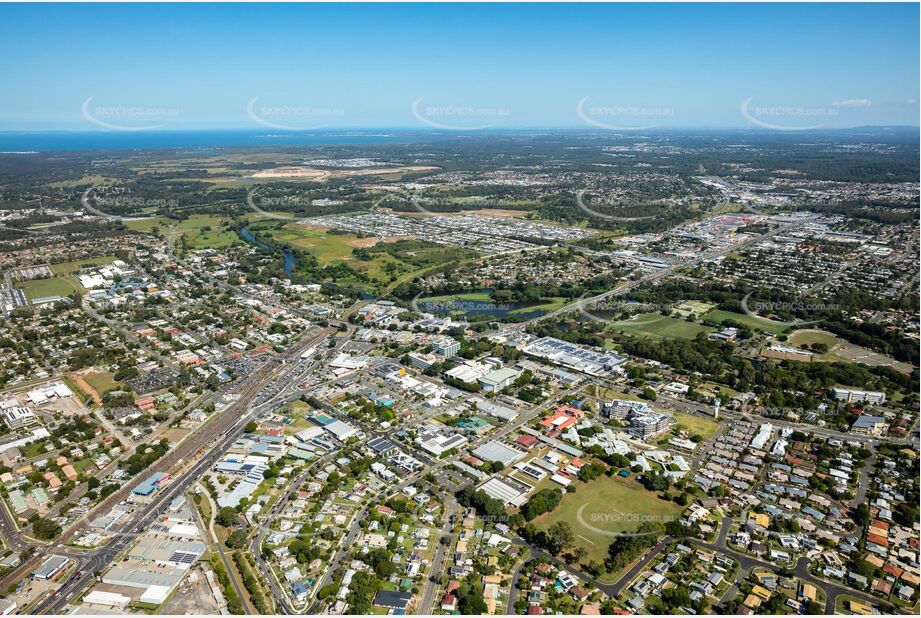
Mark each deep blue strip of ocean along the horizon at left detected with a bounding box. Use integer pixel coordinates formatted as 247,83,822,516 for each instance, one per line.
0,129,447,153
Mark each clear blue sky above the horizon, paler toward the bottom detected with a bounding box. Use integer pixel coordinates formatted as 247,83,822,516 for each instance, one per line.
0,4,919,130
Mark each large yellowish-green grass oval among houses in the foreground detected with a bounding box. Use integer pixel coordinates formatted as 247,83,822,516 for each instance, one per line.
533,474,682,562
